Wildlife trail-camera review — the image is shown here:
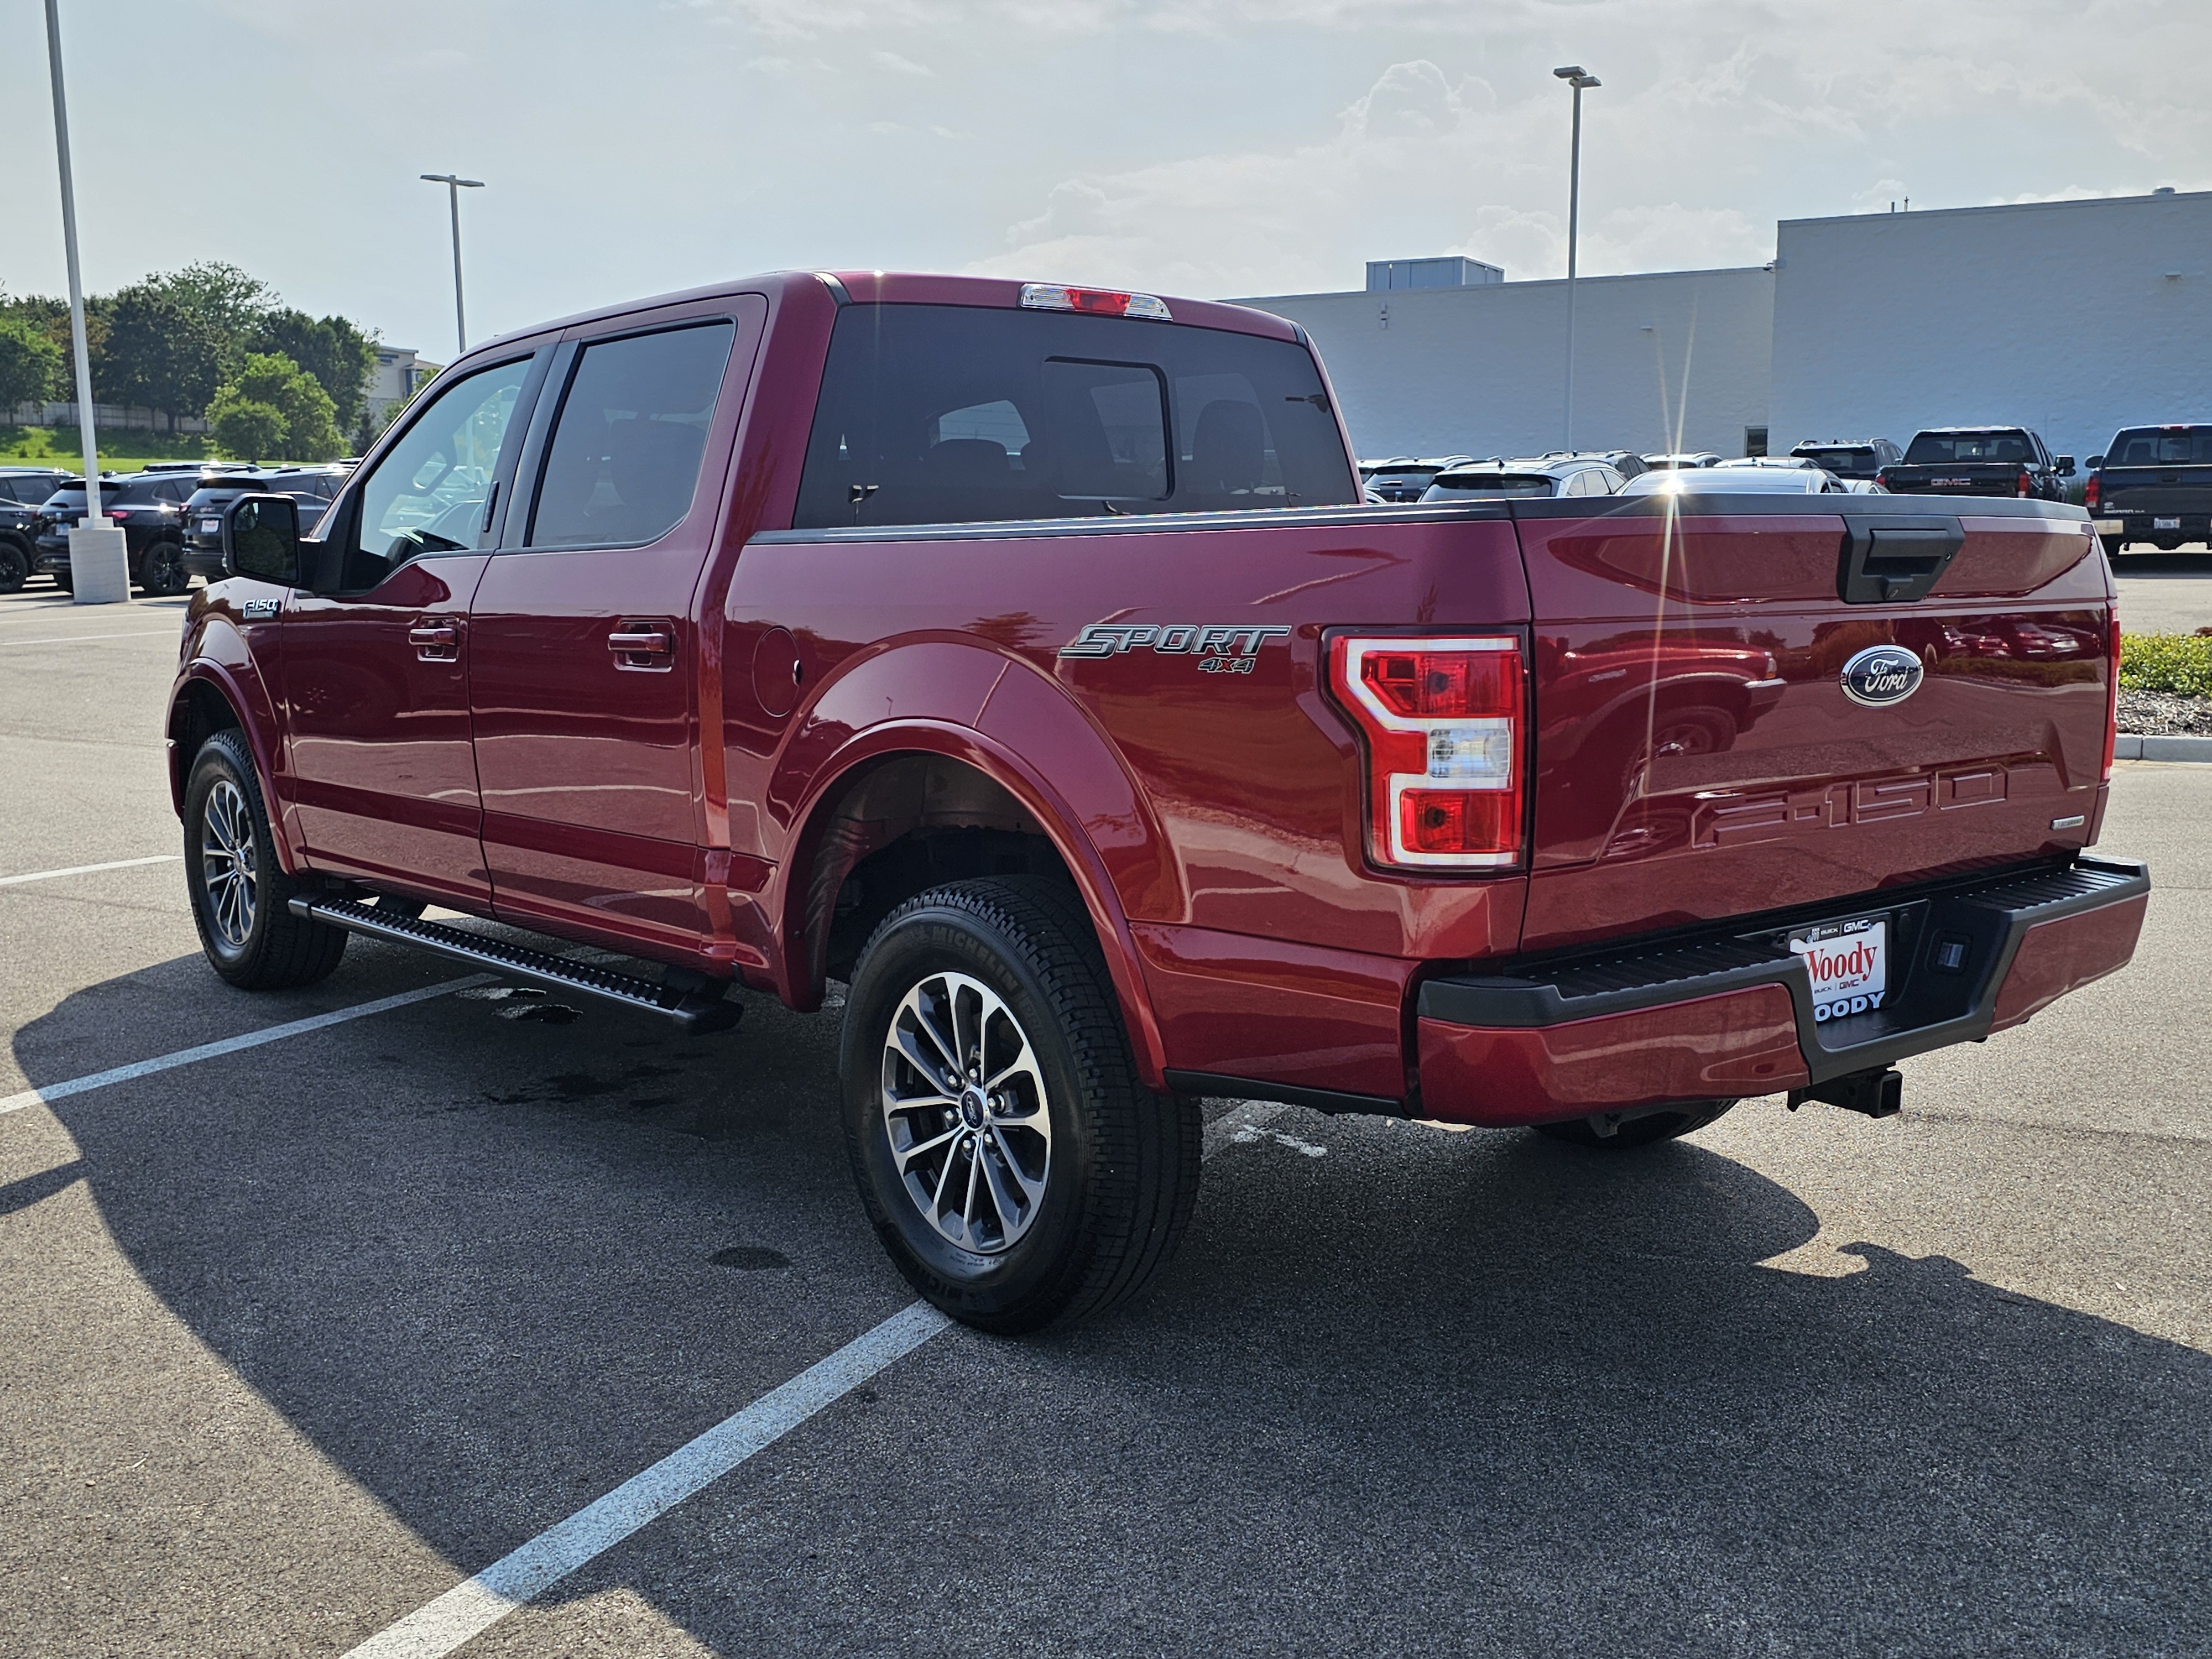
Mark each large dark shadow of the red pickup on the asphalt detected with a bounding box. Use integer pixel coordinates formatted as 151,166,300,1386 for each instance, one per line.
0,958,2212,1655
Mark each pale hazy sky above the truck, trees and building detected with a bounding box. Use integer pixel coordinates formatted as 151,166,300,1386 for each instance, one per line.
0,0,2212,361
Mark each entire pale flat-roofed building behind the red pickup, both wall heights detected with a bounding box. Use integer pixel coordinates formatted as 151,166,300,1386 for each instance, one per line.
1241,190,2212,471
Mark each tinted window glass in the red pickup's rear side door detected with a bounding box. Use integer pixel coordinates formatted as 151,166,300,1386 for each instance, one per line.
529,323,737,546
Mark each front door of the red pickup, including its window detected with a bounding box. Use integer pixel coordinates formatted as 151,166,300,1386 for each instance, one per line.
283,352,544,907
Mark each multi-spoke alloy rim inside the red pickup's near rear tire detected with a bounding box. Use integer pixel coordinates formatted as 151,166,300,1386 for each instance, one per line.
880,971,1053,1256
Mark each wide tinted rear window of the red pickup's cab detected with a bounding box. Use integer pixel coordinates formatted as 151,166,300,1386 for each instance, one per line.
794,305,1360,529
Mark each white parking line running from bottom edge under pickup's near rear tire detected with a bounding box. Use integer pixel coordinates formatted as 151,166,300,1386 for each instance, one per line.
345,1102,1285,1659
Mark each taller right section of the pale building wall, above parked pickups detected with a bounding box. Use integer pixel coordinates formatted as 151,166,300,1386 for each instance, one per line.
1772,192,2212,471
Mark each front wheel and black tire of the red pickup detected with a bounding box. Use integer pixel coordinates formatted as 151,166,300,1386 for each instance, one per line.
184,728,345,991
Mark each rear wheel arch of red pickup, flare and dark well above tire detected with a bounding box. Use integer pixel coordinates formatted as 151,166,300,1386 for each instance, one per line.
781,732,1166,1088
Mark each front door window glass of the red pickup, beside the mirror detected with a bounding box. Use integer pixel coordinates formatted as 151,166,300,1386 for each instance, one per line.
345,358,531,588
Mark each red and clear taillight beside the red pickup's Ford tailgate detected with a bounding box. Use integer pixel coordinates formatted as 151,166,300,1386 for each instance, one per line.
1329,635,1526,869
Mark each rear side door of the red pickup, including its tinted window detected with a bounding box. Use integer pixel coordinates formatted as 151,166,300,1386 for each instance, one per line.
469,296,768,949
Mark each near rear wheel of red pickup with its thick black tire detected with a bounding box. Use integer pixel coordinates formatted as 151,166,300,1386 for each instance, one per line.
841,876,1203,1336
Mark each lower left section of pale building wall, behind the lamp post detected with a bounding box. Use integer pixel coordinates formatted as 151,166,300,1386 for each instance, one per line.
1237,268,1774,458
